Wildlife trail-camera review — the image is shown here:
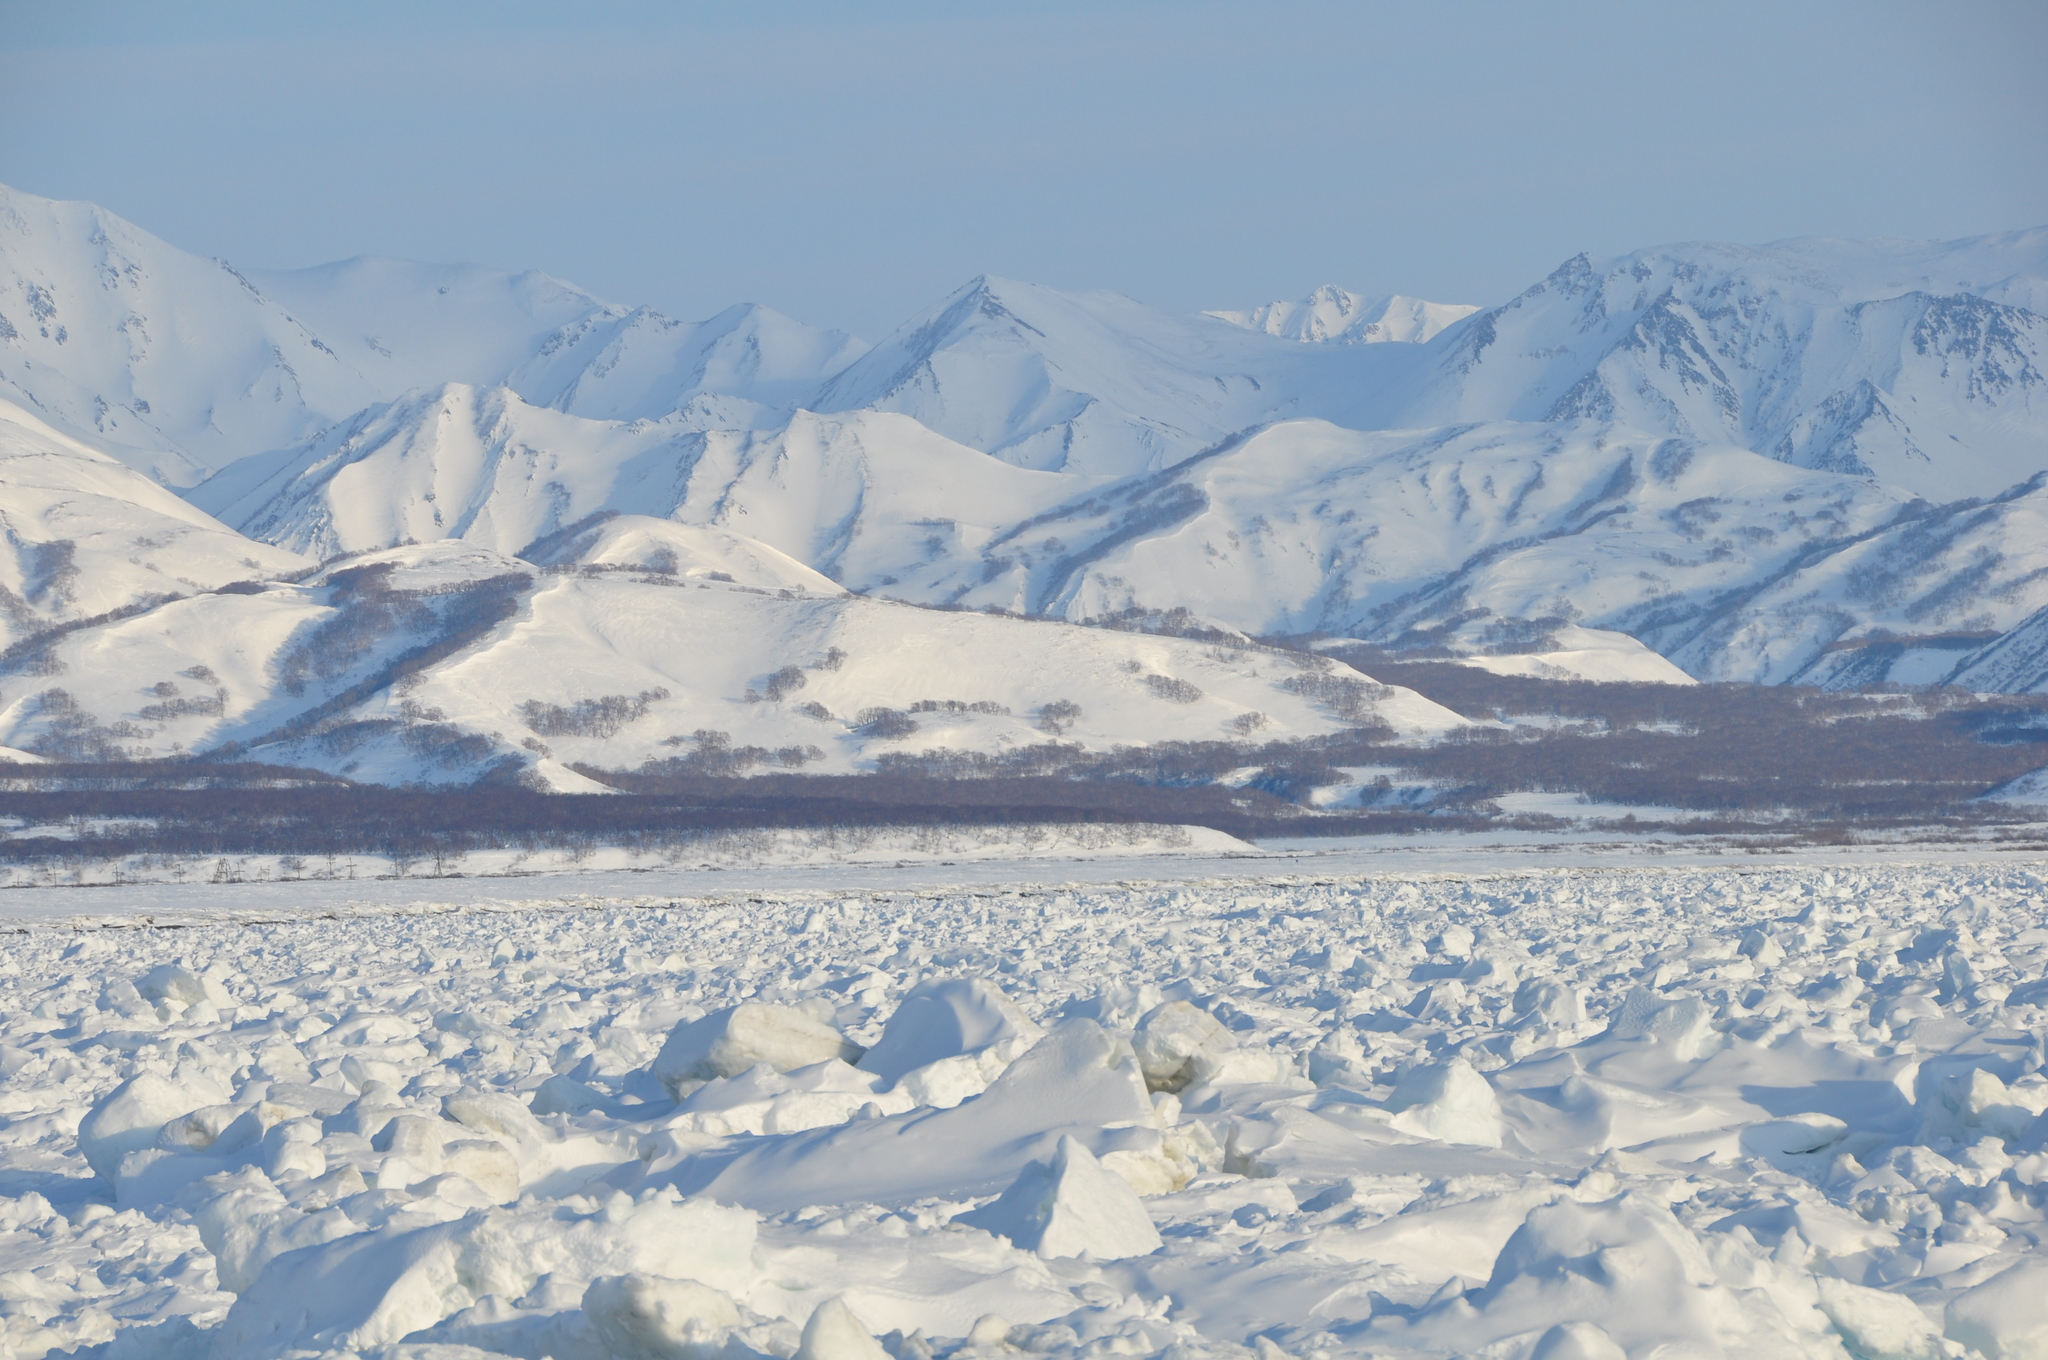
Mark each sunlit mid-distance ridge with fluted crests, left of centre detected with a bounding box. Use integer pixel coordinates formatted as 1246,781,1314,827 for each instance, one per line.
190,385,1094,588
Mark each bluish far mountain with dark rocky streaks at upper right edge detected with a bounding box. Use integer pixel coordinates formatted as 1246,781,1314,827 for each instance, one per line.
1401,229,2048,500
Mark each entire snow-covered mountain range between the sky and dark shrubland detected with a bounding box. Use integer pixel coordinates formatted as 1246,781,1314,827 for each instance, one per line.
0,188,2048,789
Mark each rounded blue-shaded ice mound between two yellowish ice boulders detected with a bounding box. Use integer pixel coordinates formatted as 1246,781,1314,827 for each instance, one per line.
860,977,1044,1110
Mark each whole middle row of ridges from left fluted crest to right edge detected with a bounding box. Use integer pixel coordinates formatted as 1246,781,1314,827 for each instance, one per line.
193,387,2048,684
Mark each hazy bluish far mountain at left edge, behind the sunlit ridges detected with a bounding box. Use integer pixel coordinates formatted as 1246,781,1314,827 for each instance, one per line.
0,186,864,487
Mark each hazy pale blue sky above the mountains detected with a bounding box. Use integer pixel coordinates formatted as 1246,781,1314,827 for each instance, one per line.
0,0,2048,336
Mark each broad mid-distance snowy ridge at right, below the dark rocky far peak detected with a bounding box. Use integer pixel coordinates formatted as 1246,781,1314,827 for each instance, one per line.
905,422,2048,682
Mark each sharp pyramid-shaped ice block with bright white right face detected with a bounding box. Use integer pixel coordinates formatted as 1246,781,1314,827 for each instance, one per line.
956,1137,1159,1262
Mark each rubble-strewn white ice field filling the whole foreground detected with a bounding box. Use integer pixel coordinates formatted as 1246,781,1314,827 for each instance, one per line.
0,860,2048,1360
